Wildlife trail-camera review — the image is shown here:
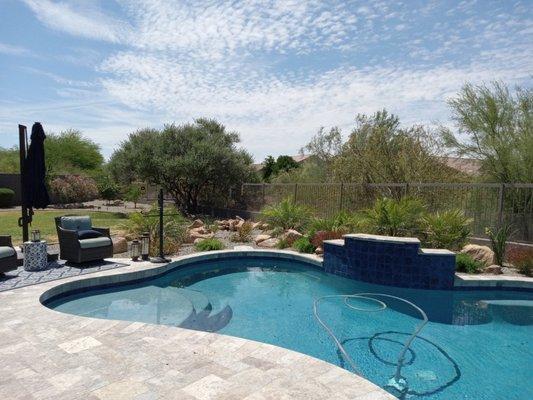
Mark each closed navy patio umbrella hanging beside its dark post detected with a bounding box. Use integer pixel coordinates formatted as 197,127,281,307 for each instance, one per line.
22,122,50,211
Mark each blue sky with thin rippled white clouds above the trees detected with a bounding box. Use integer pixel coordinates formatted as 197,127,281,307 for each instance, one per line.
0,0,533,161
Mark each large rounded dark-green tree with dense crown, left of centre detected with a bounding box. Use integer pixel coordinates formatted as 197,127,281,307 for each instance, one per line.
109,119,253,213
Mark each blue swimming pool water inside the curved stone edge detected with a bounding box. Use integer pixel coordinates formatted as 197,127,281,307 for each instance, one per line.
46,258,533,400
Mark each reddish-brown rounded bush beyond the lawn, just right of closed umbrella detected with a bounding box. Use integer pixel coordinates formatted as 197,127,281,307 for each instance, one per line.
50,175,99,204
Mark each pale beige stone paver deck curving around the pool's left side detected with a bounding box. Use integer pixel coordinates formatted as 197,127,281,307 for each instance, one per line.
0,253,394,400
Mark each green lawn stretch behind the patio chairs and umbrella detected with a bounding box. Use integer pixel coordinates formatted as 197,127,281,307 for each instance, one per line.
0,210,128,245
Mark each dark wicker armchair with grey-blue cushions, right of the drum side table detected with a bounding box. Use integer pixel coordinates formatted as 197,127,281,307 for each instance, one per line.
55,215,113,264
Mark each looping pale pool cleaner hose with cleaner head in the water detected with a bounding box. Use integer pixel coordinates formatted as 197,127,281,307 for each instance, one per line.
313,293,428,392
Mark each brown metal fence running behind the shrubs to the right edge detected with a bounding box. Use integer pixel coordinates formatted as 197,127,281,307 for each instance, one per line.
232,183,533,242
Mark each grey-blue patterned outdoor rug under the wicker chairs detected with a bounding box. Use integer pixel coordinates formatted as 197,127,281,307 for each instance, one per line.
0,260,127,292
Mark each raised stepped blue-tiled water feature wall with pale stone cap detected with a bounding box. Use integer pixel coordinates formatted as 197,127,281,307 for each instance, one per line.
324,234,455,290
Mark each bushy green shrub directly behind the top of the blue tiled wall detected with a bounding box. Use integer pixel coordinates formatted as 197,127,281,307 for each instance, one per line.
359,197,424,236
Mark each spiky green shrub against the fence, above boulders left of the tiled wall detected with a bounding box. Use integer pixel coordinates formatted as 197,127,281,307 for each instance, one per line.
261,198,311,230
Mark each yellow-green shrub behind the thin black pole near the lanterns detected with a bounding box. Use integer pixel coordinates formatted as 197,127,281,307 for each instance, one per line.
124,206,188,255
